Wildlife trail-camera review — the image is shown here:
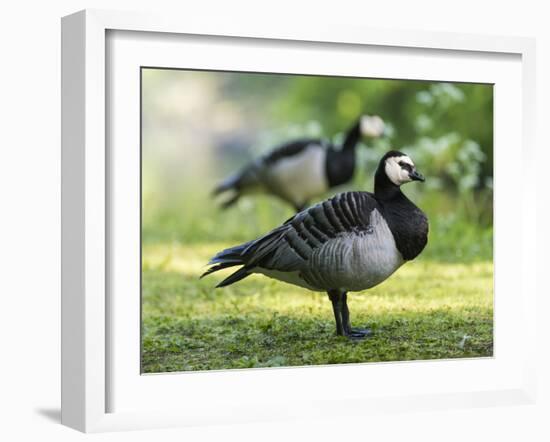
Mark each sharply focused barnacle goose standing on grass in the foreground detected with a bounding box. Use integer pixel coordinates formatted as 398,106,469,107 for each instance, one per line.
201,151,428,338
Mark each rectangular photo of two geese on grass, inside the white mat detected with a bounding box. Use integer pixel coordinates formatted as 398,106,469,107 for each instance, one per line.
140,66,494,374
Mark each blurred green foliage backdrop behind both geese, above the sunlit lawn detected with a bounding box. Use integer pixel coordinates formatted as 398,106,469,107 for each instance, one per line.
142,70,493,261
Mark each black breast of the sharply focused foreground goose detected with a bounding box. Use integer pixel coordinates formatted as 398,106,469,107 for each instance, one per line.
381,192,428,261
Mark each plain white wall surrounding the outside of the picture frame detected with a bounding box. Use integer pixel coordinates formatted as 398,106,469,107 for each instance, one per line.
0,0,550,441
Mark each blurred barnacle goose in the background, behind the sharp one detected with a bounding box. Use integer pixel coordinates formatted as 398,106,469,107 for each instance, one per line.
213,115,384,212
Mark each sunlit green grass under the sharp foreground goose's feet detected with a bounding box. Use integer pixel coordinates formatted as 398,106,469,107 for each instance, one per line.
142,242,493,373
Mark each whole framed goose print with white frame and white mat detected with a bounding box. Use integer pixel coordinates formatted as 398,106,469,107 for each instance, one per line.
62,11,536,431
